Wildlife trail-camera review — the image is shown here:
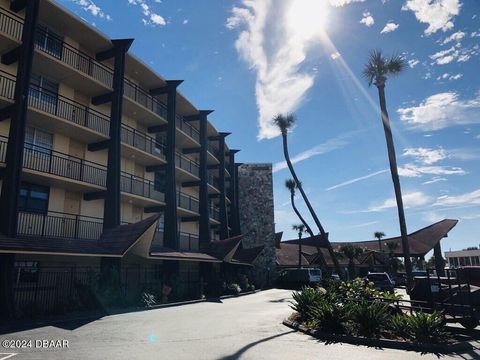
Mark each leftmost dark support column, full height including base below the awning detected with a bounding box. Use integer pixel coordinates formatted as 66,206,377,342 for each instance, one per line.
0,0,39,319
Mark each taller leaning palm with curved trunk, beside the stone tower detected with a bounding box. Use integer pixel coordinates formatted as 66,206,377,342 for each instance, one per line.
273,114,342,276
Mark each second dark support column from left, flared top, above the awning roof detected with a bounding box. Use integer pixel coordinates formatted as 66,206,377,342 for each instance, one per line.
92,39,133,230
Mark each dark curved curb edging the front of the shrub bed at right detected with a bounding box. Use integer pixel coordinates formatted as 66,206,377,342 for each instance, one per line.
283,319,473,354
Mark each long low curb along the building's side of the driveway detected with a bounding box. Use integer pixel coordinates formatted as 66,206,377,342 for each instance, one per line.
0,290,262,334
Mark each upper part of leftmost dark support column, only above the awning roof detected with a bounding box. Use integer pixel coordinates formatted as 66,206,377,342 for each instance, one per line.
0,0,39,237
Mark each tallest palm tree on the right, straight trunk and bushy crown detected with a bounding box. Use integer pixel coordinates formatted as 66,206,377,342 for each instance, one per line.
363,50,412,289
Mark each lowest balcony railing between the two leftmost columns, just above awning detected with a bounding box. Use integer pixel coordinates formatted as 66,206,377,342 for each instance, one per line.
17,211,103,240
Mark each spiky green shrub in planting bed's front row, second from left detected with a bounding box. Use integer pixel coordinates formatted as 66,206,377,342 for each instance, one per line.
310,298,348,334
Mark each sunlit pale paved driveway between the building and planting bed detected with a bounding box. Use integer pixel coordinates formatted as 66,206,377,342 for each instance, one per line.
0,290,480,360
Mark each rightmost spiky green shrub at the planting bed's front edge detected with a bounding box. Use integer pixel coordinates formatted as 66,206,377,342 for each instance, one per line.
407,311,451,344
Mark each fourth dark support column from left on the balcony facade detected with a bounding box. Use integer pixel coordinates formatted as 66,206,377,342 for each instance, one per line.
199,110,212,244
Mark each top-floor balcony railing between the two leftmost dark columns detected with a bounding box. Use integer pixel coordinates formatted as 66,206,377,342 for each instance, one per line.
35,27,113,88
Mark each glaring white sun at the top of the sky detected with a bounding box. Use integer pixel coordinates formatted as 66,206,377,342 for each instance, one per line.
286,0,330,39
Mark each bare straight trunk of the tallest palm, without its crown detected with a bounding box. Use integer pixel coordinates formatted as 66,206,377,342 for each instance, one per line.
377,85,413,290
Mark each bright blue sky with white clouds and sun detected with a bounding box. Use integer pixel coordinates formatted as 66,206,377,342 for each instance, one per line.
58,0,480,257
